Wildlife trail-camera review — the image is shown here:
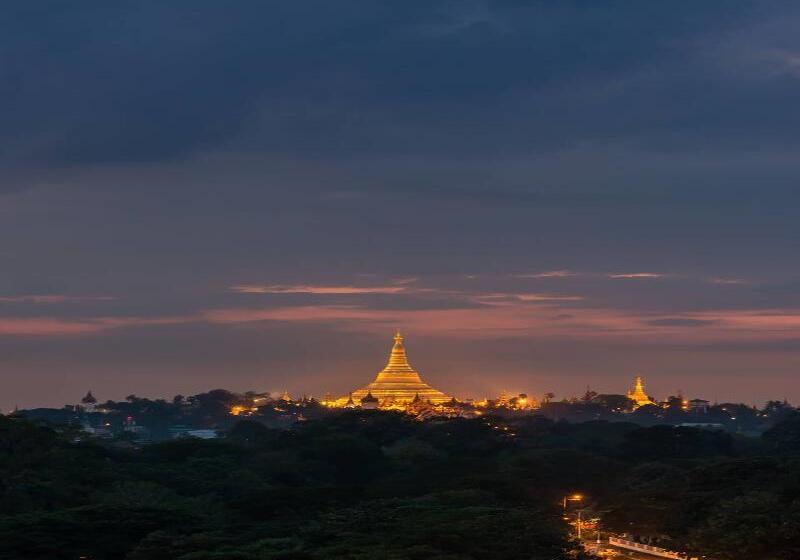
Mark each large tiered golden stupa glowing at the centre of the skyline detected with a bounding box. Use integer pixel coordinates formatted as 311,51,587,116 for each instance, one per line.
340,332,452,408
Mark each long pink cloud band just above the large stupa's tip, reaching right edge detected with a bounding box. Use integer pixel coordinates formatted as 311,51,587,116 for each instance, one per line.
204,301,800,344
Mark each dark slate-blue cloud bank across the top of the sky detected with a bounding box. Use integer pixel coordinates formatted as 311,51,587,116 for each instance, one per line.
0,0,780,174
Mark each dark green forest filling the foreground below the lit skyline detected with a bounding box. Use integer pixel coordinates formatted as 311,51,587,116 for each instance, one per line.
0,410,800,560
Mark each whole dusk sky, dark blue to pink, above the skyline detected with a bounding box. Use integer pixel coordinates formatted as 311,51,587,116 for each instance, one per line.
0,0,800,411
